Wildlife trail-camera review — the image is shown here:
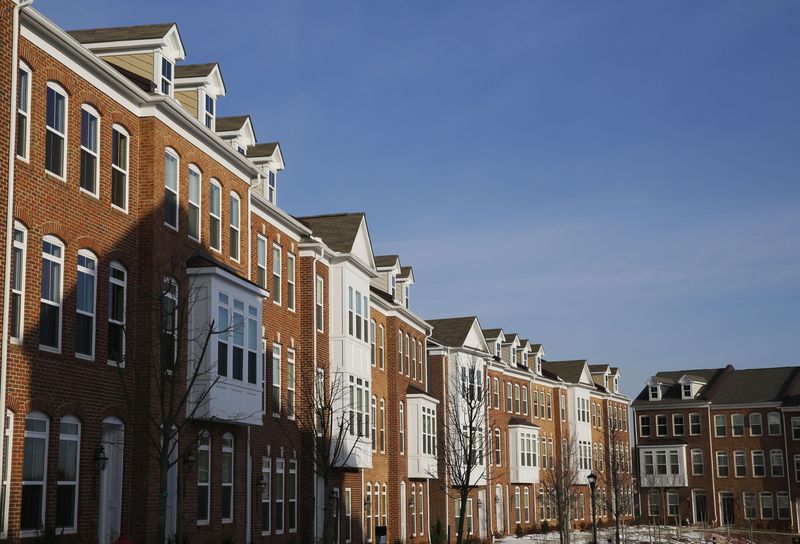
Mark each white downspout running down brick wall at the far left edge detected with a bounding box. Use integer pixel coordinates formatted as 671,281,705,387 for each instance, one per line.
0,0,33,506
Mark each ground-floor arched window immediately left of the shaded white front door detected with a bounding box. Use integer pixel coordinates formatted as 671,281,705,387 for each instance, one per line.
56,416,81,530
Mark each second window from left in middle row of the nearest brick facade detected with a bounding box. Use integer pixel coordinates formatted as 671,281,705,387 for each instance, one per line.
39,236,64,352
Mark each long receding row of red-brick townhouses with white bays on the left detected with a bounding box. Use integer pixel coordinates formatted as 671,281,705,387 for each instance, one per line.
0,0,636,544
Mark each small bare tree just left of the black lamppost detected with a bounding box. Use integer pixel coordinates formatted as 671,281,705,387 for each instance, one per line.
541,433,581,544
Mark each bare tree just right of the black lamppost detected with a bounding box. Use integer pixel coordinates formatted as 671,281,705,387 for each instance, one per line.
600,420,636,544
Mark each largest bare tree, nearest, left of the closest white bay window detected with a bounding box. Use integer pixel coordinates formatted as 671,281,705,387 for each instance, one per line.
113,263,241,543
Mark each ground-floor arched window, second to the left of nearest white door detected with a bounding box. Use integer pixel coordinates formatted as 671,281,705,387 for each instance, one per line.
20,412,49,532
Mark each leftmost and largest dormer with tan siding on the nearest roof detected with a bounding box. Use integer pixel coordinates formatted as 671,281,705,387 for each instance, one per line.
69,23,186,97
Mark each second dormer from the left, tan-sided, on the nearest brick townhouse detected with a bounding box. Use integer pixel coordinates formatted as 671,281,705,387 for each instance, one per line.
175,62,225,130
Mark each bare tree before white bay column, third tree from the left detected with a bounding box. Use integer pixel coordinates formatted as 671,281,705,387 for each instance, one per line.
434,354,489,544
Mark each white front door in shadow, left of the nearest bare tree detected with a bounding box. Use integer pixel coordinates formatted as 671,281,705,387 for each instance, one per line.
97,418,125,544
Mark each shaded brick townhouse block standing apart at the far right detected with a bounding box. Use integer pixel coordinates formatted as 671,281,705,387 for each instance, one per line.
633,365,800,531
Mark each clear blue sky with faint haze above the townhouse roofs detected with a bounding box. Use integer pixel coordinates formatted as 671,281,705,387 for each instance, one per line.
39,0,800,394
